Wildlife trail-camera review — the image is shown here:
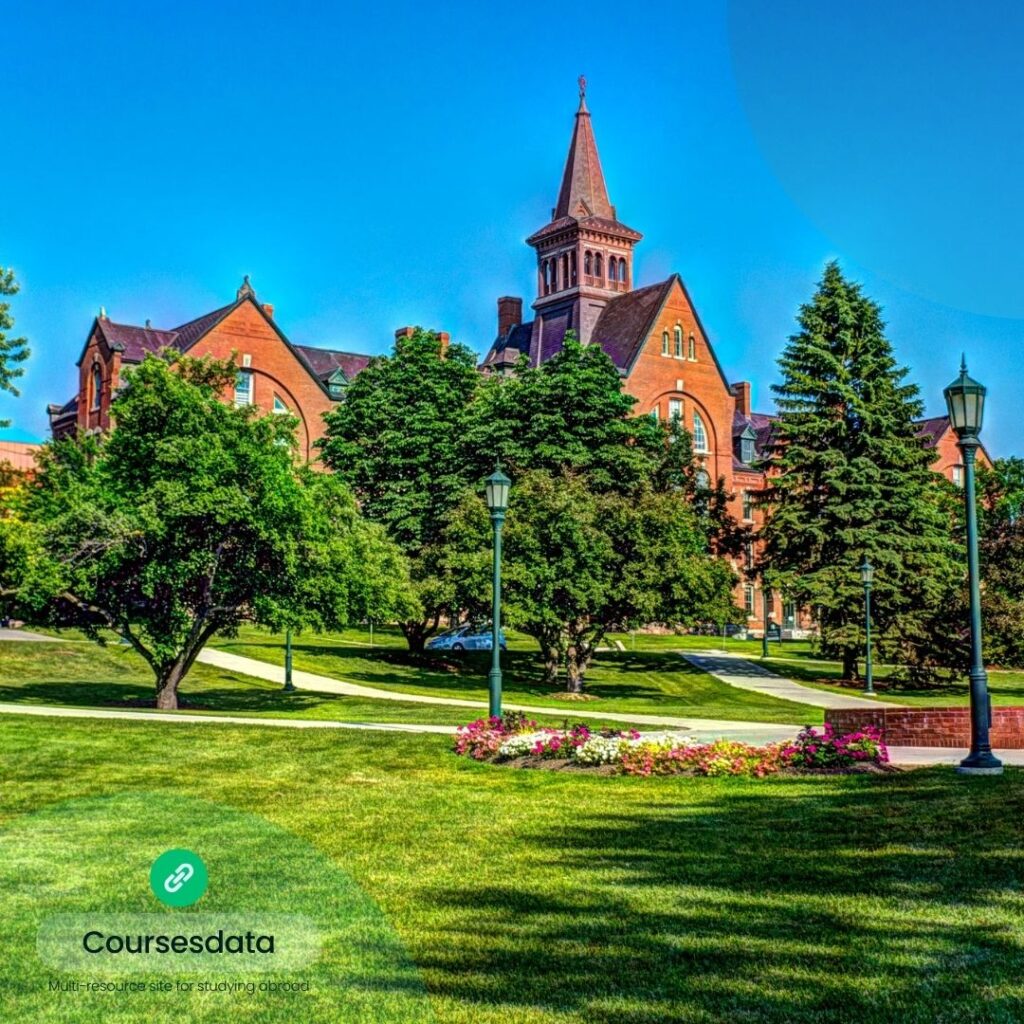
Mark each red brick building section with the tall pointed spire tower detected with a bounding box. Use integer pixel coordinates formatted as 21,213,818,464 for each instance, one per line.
483,79,987,632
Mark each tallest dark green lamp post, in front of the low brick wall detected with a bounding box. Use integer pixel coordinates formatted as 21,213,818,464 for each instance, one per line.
942,358,1002,775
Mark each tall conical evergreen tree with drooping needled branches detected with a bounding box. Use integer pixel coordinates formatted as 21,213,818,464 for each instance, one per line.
761,263,958,678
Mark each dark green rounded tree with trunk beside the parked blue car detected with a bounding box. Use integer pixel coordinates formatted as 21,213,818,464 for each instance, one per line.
321,329,480,650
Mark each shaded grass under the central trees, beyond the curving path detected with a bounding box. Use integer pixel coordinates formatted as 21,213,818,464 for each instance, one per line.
213,629,822,724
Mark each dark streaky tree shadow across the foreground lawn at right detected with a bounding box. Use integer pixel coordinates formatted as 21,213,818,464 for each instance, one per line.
420,770,1024,1024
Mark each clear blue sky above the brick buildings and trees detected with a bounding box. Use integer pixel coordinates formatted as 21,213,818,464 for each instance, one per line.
0,0,1024,455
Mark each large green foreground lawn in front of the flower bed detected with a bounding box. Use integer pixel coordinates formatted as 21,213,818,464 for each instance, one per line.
0,717,1024,1024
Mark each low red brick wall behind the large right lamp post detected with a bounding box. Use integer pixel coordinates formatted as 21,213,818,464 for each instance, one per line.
825,708,1024,751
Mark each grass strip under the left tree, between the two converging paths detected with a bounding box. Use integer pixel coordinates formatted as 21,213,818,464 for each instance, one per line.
0,640,614,727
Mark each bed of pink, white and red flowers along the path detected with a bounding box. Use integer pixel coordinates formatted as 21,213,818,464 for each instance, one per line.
455,713,889,778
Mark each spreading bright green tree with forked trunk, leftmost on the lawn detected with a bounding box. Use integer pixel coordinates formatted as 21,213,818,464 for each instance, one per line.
18,356,409,708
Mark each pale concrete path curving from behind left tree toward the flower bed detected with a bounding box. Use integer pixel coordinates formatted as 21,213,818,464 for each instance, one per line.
197,647,801,743
